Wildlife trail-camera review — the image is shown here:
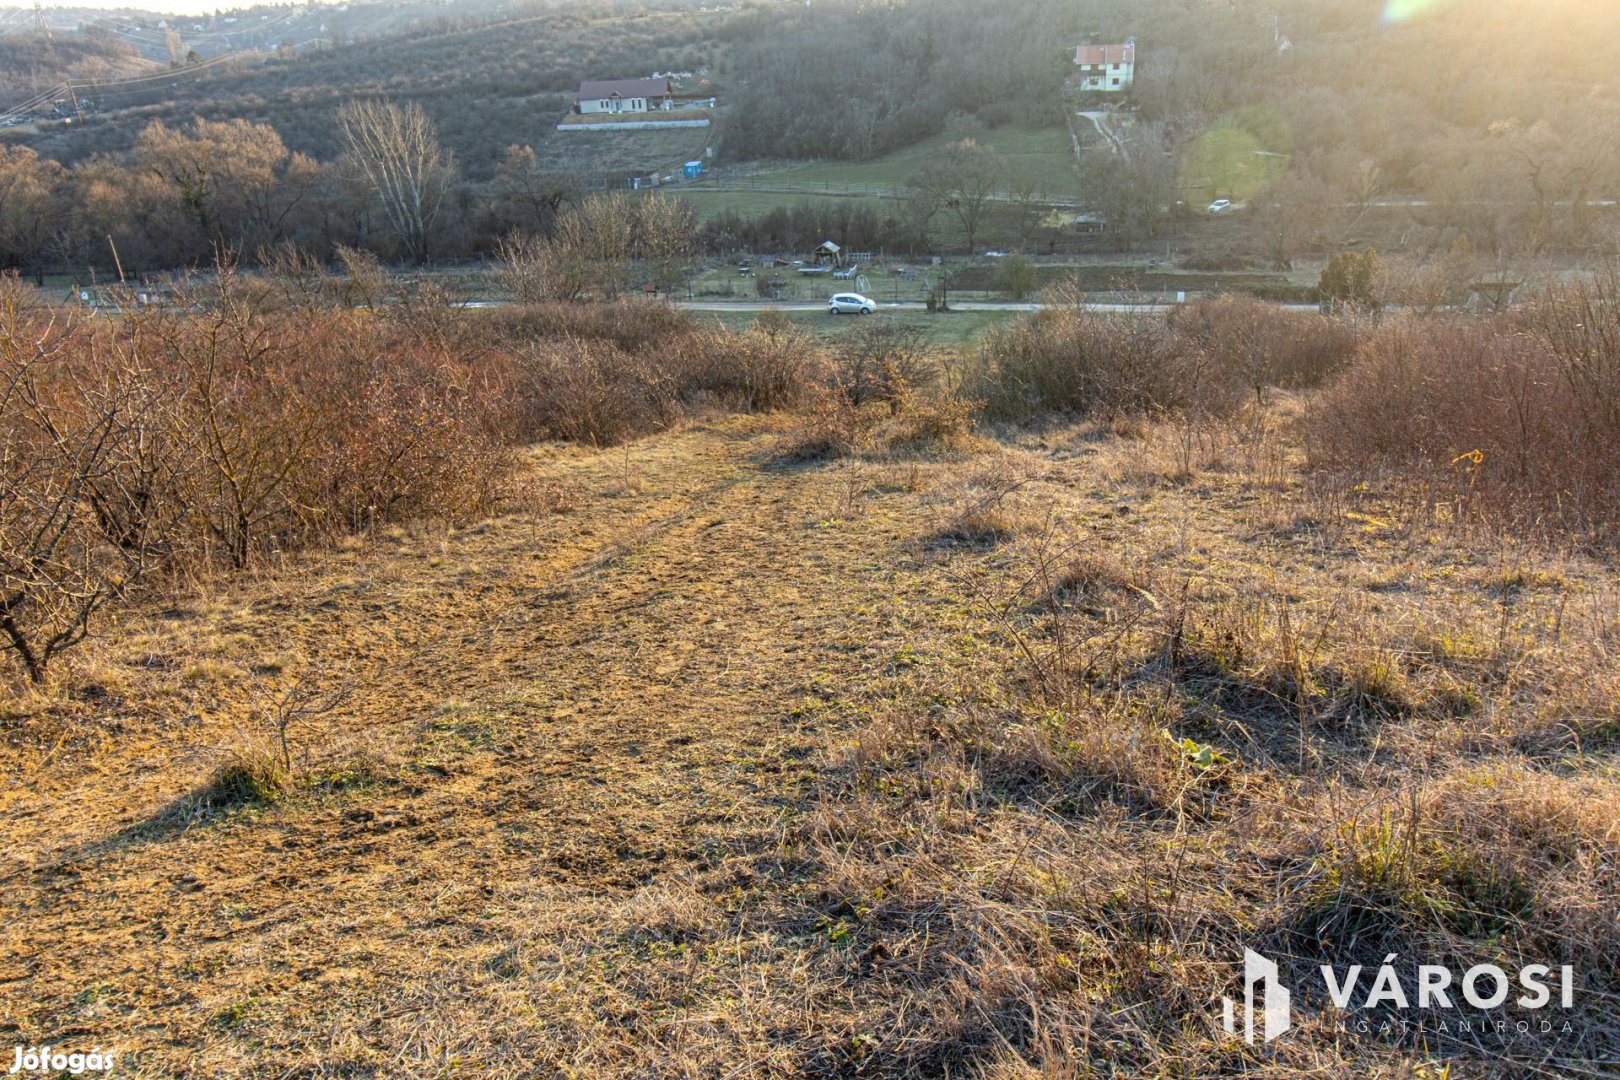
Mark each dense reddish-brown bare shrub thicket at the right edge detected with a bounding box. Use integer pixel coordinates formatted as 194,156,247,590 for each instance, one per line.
1304,277,1620,544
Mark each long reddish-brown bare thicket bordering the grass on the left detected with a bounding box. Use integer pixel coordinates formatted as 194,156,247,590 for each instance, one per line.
0,283,816,680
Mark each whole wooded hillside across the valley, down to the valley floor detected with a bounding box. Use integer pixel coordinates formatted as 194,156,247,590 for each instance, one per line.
0,0,1620,279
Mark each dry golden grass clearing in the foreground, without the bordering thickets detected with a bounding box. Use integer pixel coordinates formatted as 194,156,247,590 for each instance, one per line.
0,398,1620,1077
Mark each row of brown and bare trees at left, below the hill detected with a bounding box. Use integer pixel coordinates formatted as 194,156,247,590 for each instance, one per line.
0,100,602,280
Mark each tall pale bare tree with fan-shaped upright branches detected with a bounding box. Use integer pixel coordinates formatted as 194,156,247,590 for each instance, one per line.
337,102,455,266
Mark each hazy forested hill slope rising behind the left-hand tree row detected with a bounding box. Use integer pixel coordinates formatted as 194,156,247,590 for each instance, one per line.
0,0,1620,267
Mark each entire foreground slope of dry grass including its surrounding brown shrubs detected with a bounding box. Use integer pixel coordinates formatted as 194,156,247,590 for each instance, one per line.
0,295,1620,1080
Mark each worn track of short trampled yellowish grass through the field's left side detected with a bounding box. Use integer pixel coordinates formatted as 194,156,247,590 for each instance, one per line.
0,421,959,1075
